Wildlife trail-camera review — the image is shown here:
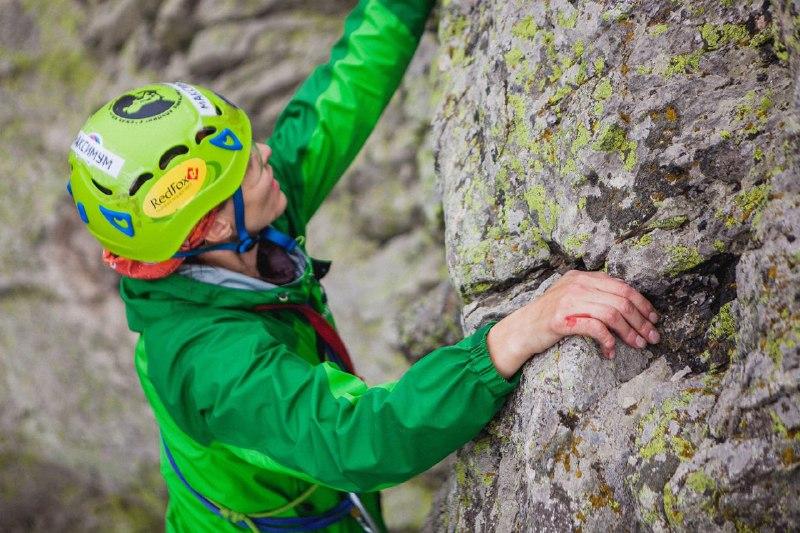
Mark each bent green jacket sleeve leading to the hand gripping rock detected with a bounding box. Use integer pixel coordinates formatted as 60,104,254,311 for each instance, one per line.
190,324,519,492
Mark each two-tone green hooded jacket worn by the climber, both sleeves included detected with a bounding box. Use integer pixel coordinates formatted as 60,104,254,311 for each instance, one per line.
120,0,516,532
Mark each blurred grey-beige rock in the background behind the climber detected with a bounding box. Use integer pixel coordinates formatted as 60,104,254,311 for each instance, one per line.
0,0,450,531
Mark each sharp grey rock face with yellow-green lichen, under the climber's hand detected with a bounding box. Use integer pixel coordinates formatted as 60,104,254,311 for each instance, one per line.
427,0,800,531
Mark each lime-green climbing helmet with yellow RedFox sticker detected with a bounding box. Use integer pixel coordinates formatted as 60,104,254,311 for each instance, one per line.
67,82,252,262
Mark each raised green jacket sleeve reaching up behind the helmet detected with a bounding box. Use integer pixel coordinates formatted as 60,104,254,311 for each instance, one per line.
267,0,433,226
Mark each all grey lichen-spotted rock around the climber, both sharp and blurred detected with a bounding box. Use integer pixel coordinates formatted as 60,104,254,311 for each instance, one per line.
7,0,800,531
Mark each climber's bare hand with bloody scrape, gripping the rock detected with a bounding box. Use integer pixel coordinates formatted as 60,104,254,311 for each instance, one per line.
487,270,659,377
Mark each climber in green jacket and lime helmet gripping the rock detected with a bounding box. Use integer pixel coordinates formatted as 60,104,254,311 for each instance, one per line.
67,0,658,532
